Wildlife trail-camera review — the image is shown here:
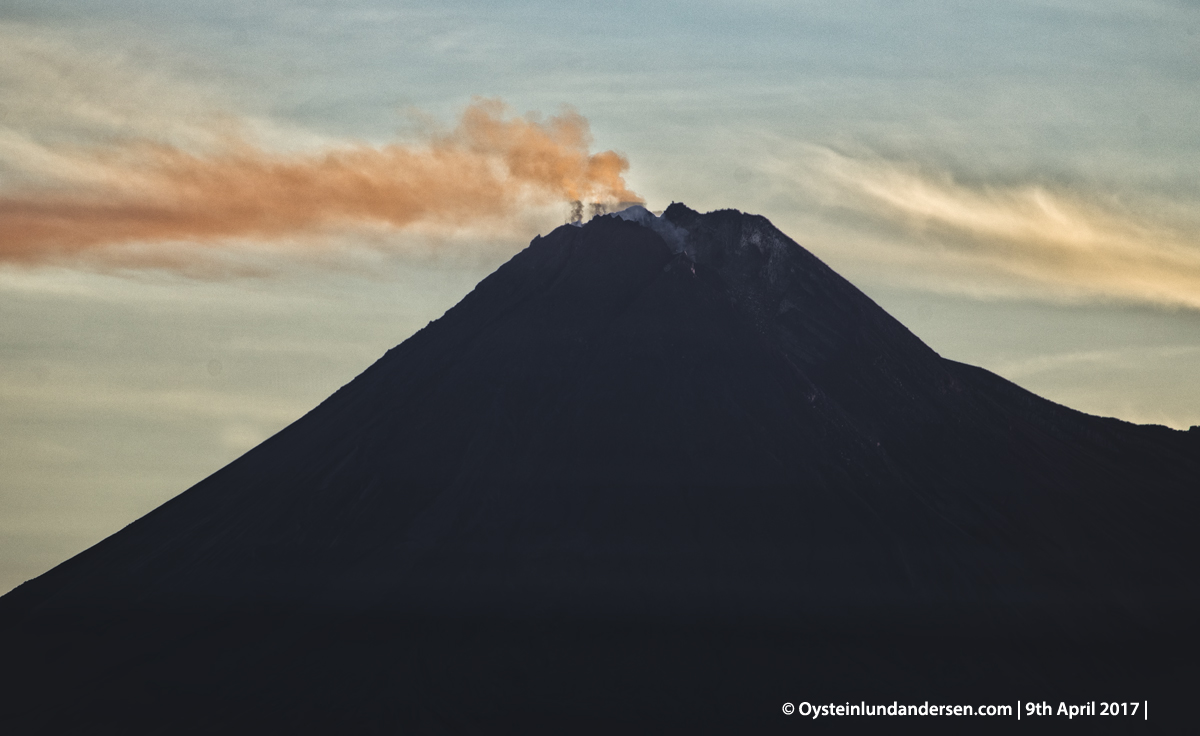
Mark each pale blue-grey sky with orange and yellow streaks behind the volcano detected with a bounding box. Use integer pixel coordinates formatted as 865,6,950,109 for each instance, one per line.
0,0,1200,592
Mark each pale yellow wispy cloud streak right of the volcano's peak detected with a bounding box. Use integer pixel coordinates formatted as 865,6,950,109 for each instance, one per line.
809,148,1200,309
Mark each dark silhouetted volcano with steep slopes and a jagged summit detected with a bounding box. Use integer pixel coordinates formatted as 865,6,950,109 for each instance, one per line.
0,204,1200,734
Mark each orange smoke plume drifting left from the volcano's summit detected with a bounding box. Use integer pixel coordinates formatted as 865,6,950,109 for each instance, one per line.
0,100,641,263
